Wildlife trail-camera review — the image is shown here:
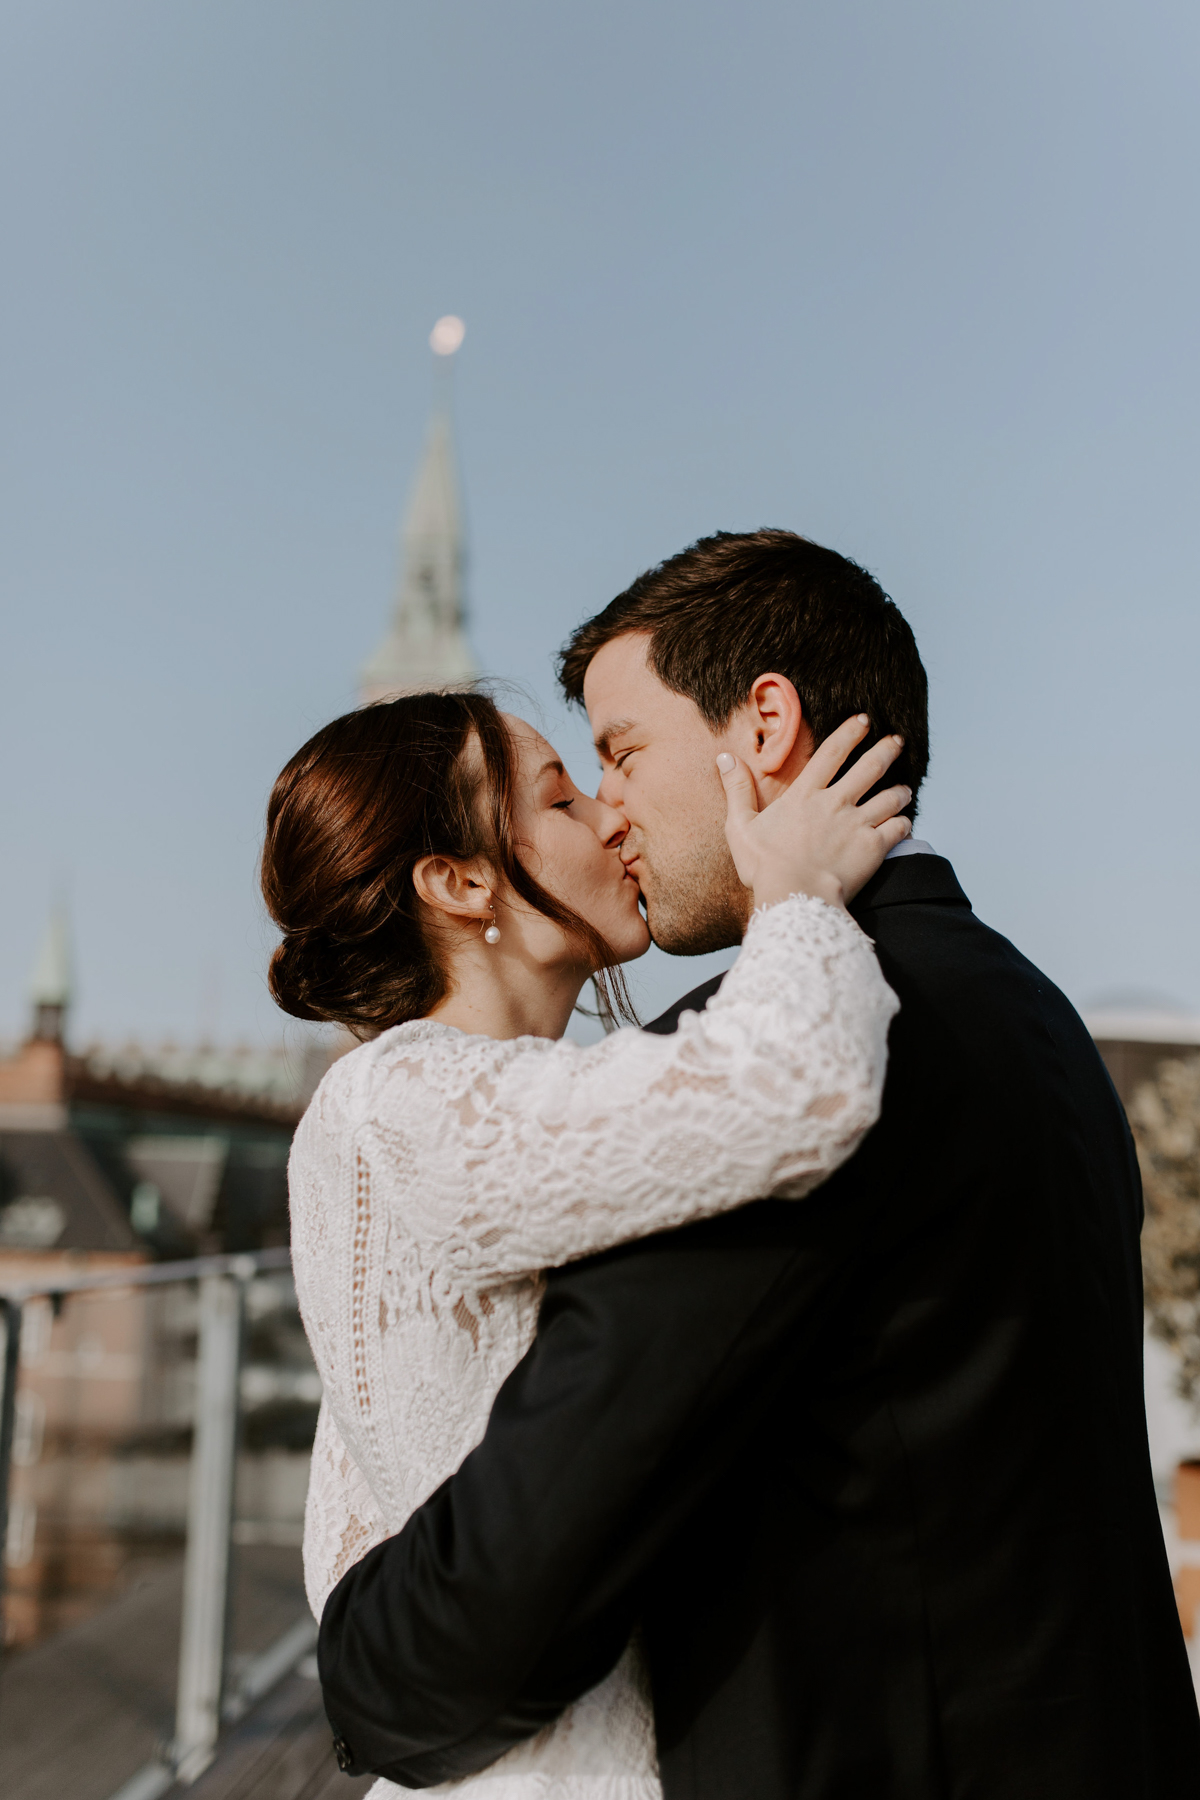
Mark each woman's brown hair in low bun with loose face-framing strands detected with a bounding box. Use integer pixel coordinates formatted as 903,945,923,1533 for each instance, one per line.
261,693,633,1037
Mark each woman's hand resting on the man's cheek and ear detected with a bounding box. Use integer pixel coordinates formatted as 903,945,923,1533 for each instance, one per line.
716,713,912,907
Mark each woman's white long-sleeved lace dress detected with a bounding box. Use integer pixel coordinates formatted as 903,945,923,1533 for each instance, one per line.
290,896,896,1800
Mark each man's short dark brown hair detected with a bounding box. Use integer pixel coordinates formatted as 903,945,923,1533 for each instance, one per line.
558,531,928,812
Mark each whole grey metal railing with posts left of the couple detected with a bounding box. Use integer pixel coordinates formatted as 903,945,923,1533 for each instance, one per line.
0,1249,317,1800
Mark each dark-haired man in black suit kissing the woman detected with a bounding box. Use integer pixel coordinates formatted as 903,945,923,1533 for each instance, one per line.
320,531,1200,1800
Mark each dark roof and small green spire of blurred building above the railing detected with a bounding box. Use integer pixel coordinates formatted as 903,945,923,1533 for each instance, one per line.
0,916,309,1276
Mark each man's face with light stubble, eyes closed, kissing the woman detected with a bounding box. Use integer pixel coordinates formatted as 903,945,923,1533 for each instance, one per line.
583,632,748,956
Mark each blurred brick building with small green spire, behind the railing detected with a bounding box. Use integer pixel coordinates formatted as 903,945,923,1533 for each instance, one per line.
0,914,318,1643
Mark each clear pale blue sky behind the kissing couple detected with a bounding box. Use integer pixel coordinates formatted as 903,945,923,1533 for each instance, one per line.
0,0,1200,1040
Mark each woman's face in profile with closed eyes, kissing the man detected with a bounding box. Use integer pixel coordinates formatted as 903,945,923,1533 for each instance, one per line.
506,715,649,963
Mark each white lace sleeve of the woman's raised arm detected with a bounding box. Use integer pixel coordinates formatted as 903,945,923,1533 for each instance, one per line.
356,896,898,1285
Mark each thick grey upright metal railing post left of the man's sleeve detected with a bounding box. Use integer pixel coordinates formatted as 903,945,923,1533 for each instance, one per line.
173,1274,243,1782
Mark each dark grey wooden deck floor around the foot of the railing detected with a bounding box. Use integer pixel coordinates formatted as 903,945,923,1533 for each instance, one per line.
0,1546,371,1800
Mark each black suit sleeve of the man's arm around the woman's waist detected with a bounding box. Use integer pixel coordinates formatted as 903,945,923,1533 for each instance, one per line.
318,1190,860,1787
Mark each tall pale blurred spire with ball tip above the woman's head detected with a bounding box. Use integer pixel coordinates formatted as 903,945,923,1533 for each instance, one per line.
362,319,477,702
